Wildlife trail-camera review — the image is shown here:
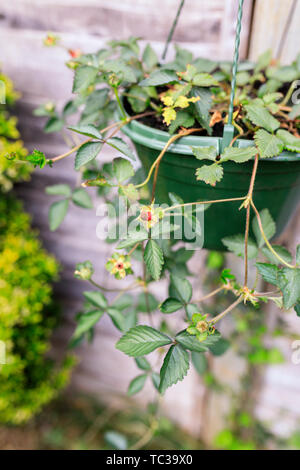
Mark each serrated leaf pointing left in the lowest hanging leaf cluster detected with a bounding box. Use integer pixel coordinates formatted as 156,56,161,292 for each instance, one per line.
116,325,172,357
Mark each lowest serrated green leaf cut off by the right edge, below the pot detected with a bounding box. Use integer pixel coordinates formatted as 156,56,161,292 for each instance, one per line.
278,268,300,310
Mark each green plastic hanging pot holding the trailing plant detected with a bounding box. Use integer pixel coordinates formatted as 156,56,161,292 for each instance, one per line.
123,121,300,251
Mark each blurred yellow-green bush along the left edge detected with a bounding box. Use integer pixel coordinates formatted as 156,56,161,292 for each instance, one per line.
0,74,74,424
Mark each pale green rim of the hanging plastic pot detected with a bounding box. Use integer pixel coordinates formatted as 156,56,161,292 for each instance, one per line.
122,116,300,162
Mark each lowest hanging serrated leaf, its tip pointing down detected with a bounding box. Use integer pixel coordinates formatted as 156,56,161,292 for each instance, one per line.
159,344,189,394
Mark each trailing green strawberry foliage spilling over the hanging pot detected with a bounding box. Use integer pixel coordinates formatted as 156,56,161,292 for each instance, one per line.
31,37,300,400
